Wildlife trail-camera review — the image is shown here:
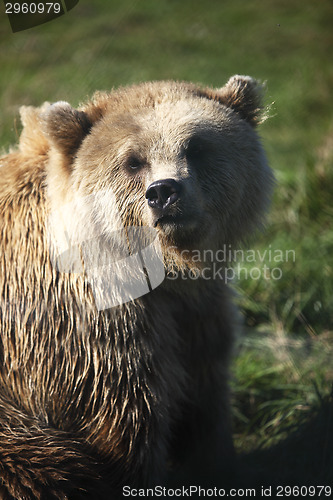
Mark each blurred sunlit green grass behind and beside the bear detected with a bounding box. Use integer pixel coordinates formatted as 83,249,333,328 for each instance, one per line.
0,0,333,490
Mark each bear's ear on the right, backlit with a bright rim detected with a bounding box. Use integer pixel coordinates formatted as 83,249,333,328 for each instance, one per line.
202,75,264,126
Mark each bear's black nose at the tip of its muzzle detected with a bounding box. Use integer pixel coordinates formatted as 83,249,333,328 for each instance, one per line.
146,179,181,210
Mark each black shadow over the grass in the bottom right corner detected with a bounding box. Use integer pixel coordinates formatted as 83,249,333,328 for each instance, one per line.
168,391,333,498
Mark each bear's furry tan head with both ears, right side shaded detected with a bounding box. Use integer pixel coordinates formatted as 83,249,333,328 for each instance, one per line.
41,76,273,290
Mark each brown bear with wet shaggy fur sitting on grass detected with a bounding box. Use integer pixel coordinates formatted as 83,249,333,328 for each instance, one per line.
0,76,273,499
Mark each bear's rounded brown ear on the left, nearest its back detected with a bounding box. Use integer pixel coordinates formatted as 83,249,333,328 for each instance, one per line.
40,101,92,159
